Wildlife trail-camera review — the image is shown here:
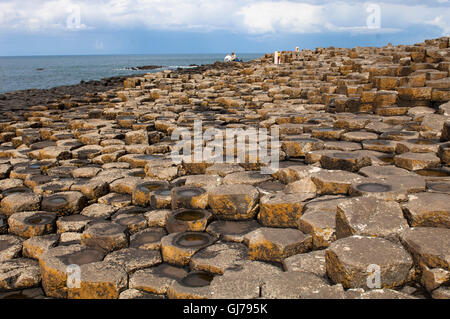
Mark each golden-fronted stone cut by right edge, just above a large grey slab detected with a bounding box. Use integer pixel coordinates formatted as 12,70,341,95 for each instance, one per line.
403,193,450,228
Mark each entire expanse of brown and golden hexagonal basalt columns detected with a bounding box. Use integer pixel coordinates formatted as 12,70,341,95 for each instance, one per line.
0,37,450,299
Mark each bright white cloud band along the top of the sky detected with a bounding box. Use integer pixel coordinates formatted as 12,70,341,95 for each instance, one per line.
0,0,450,36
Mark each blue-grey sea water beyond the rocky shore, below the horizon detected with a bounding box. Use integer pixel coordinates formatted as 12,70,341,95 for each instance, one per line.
0,53,264,93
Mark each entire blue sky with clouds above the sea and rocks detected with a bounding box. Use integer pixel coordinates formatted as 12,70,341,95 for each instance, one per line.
0,0,450,56
